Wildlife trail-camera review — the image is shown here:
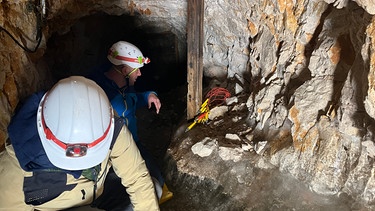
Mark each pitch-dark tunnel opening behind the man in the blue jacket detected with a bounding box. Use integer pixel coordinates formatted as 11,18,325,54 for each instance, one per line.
45,13,187,92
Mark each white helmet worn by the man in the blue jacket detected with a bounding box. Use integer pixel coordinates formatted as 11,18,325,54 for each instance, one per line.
107,41,150,68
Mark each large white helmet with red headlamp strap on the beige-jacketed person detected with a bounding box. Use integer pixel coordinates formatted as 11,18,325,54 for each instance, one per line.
37,76,114,170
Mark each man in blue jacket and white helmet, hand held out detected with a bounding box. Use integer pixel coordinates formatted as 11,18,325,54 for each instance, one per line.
90,41,173,203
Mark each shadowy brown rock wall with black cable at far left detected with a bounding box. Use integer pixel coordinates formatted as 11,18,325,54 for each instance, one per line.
0,1,50,148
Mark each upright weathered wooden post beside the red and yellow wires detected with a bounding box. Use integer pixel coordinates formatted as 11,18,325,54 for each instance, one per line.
187,0,204,119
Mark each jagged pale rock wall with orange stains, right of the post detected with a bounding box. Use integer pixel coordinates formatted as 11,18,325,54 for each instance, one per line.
247,1,375,203
